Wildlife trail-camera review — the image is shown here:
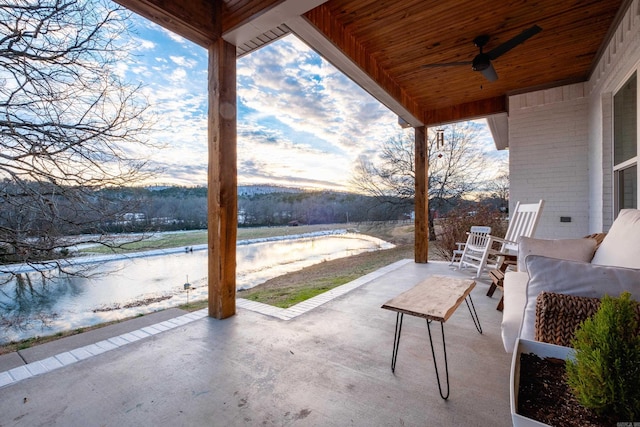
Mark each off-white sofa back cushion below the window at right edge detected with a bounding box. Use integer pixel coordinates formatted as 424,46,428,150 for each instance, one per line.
591,209,640,268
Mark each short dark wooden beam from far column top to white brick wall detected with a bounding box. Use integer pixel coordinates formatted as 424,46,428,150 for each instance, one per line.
424,96,508,126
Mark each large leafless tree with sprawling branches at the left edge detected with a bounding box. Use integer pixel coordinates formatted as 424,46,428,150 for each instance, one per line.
0,0,157,271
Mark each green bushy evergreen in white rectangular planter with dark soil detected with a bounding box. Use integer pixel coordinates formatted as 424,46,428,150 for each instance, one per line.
510,293,640,426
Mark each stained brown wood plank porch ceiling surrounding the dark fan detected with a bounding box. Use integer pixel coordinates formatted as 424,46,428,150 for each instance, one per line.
117,0,631,122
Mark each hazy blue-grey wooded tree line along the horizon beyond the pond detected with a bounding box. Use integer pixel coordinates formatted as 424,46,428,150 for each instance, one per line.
0,184,413,263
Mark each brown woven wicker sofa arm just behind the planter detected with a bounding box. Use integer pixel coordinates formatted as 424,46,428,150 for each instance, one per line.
535,292,600,347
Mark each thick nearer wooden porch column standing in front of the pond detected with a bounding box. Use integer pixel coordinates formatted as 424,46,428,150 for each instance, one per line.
207,37,238,319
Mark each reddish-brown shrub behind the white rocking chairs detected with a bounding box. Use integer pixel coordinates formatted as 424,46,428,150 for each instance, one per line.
434,206,508,260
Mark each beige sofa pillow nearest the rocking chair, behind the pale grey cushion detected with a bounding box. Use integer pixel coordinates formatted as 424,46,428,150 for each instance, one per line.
518,237,597,271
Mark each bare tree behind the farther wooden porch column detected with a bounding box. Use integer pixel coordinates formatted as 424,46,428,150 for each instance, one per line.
352,122,486,239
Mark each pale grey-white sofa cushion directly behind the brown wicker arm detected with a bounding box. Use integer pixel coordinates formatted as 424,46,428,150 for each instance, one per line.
520,255,640,340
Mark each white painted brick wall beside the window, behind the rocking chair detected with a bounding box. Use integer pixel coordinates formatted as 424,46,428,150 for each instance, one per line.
509,0,640,234
